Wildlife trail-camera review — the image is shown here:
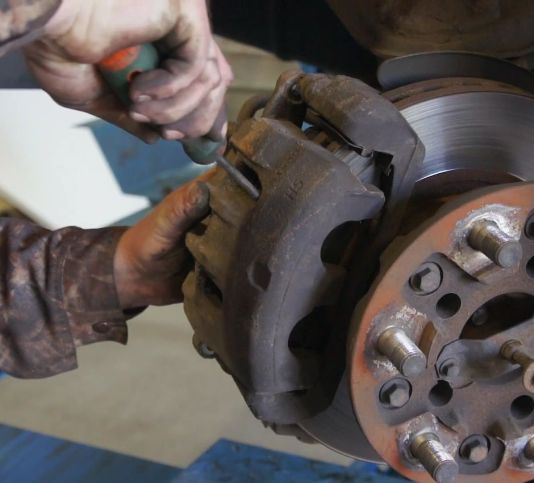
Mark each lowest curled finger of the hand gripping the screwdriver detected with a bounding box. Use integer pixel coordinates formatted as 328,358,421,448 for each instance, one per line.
162,84,227,140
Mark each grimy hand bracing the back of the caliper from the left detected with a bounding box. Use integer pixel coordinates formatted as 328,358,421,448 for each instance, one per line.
114,172,212,309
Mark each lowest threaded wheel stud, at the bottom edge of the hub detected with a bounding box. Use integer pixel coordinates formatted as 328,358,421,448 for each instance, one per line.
410,433,458,483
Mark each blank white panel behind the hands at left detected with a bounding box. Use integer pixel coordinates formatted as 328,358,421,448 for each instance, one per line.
0,90,148,228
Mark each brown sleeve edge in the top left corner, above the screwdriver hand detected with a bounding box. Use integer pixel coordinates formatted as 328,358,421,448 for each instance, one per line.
0,0,61,55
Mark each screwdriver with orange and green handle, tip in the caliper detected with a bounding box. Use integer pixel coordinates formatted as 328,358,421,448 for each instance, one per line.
98,44,260,200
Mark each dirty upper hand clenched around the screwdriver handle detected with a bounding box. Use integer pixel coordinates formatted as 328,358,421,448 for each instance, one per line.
25,0,232,142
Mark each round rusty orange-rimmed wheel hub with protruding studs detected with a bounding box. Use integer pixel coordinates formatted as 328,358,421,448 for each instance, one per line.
349,183,534,481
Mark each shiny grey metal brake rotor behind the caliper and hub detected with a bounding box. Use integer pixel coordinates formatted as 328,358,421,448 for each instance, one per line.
300,79,534,462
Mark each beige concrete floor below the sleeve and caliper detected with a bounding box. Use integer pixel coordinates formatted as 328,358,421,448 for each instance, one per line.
0,306,349,467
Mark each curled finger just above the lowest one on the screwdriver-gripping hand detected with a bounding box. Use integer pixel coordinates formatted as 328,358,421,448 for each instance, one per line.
130,61,222,125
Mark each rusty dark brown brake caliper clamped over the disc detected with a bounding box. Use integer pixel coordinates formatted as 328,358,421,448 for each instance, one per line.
184,72,424,434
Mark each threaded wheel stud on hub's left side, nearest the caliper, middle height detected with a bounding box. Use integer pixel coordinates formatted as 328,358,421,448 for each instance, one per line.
377,327,426,377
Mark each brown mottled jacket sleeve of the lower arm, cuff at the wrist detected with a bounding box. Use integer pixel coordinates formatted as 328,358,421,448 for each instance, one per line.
0,218,134,378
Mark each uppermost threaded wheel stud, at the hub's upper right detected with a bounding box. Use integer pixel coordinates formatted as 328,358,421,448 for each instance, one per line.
467,220,523,268
